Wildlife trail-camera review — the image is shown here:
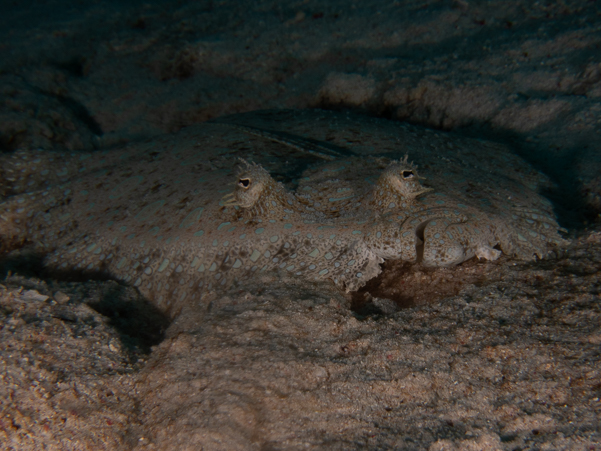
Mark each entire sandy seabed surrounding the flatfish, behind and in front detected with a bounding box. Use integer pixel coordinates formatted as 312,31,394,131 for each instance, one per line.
0,1,601,450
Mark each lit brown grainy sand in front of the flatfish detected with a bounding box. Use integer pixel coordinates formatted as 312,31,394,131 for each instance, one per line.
1,233,601,450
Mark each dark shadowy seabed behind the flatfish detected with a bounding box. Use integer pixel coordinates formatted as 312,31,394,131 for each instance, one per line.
0,0,601,219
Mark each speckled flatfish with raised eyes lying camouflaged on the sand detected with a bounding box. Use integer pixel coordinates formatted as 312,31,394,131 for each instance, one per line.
0,111,565,312
